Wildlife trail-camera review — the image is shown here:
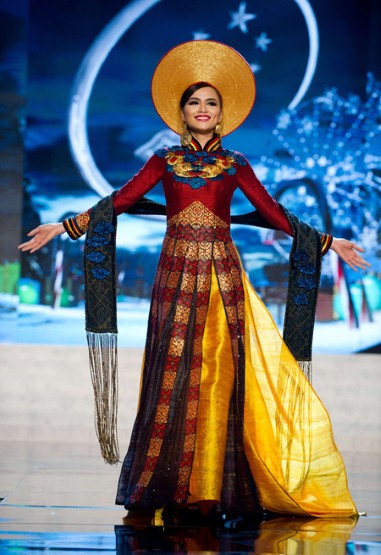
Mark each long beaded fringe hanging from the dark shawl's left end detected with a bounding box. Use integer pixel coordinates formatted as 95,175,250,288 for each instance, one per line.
86,331,119,464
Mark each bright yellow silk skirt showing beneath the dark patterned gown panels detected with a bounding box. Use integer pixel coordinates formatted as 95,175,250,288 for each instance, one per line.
189,262,357,517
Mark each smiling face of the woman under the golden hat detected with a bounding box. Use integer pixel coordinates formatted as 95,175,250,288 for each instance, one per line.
181,87,222,140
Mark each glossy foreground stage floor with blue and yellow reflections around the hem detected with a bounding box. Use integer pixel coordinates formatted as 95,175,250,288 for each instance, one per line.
0,442,381,555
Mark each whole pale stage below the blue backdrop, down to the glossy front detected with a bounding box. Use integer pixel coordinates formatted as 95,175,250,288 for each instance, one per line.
0,345,381,555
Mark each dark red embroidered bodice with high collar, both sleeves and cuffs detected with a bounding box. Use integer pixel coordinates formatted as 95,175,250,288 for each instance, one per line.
64,136,329,254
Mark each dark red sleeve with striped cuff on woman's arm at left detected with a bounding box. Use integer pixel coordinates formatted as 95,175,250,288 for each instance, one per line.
63,154,165,239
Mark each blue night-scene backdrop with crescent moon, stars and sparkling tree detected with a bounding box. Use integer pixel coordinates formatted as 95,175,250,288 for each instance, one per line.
1,0,381,347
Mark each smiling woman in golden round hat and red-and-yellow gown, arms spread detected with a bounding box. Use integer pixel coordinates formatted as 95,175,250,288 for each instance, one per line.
20,41,368,516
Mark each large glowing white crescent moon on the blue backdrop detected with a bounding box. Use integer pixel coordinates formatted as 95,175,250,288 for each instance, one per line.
68,0,319,197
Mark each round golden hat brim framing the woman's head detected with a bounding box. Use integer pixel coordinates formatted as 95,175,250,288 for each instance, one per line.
151,40,256,135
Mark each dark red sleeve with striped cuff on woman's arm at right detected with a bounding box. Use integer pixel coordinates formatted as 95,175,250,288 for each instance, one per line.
236,155,332,254
